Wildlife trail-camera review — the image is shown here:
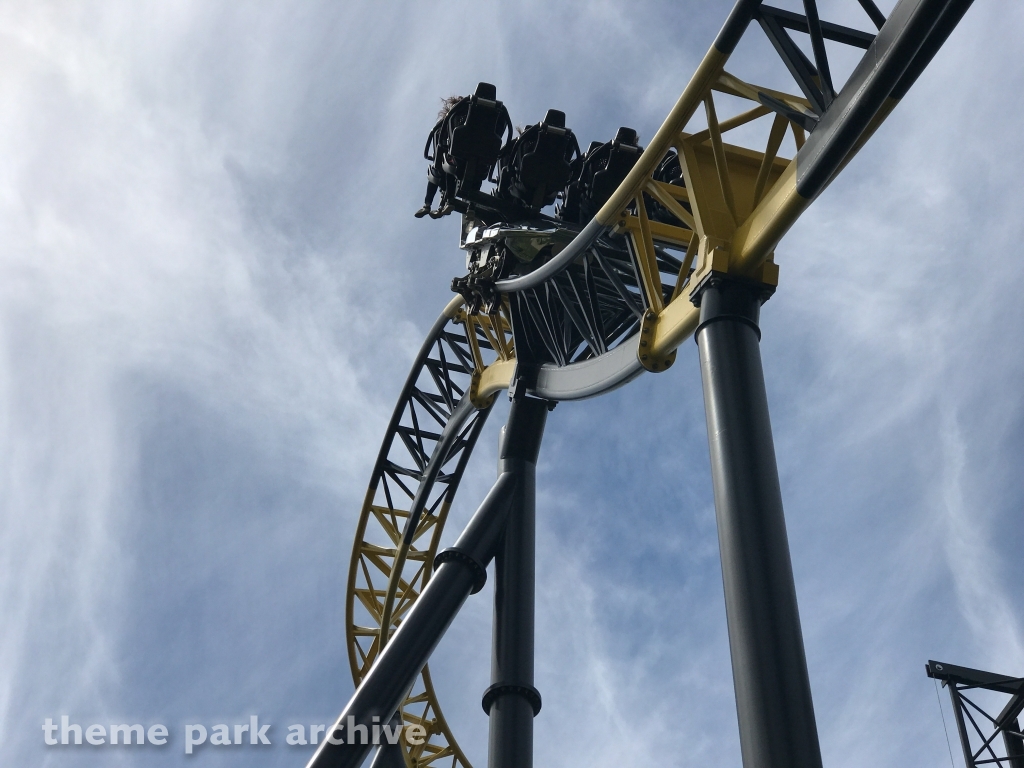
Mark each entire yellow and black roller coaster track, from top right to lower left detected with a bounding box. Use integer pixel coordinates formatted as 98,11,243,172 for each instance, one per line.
337,0,970,768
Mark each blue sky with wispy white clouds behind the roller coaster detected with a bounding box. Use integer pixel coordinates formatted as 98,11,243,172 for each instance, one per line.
0,0,1024,768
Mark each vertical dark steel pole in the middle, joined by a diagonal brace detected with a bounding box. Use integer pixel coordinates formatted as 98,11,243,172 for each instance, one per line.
483,396,550,768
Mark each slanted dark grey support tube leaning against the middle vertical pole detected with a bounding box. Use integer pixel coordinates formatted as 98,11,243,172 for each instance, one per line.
307,472,517,768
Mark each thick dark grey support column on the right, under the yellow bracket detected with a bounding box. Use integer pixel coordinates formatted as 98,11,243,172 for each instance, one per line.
695,275,821,768
